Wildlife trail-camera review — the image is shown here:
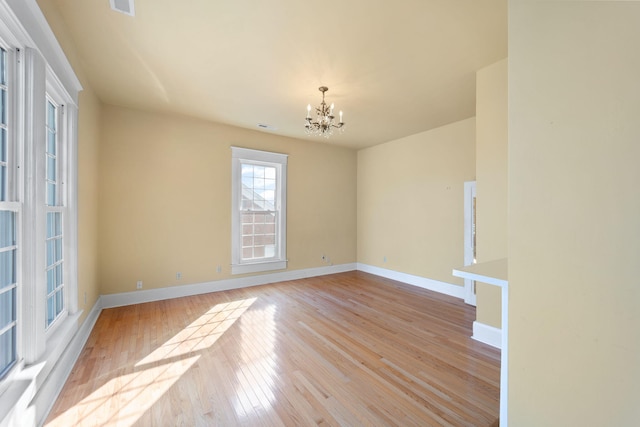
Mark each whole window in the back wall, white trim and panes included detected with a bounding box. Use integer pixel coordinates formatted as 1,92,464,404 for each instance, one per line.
231,147,287,274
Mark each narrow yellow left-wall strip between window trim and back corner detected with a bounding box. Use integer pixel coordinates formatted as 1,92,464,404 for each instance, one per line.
38,1,102,323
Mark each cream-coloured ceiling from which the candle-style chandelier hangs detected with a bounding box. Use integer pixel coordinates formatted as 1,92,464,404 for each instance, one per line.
52,0,507,148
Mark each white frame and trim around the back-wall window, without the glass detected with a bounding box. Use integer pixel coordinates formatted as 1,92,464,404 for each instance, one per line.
231,147,288,274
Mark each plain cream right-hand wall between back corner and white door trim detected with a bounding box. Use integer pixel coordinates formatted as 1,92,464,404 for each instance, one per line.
358,118,475,286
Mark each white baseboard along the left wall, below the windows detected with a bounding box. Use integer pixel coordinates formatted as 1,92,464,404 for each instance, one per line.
30,297,102,425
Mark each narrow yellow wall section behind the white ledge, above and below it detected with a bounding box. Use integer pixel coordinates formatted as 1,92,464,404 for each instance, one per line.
476,59,508,328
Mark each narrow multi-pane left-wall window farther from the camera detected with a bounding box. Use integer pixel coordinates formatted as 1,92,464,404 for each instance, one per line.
45,99,65,327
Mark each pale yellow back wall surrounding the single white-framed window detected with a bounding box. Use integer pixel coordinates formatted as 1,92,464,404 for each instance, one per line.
98,106,356,294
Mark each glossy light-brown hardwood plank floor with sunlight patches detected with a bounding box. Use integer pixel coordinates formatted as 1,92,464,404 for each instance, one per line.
46,272,500,427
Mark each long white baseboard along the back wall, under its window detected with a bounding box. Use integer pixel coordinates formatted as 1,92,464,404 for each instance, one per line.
101,263,356,308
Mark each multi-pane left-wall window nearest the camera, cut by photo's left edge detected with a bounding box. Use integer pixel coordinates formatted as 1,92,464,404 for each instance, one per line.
0,48,18,378
